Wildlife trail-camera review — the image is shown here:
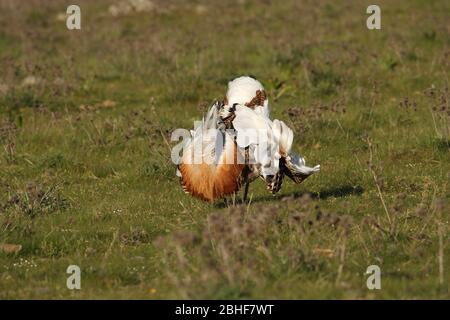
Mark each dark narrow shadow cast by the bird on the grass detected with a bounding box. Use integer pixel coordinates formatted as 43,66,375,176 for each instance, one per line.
215,185,364,208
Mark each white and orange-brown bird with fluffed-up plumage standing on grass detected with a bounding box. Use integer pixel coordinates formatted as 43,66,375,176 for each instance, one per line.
177,76,320,201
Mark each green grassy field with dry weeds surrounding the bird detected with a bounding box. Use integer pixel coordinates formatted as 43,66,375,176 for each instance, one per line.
0,0,450,299
